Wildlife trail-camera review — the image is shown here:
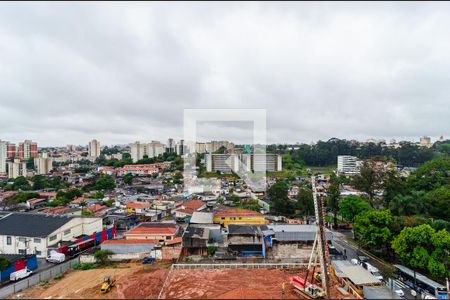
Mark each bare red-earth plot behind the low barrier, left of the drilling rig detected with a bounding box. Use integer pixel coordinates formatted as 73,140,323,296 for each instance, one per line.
161,269,299,299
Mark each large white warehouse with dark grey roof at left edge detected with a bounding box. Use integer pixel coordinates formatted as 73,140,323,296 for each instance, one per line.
0,212,103,257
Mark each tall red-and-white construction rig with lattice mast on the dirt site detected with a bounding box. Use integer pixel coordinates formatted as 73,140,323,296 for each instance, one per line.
291,176,331,298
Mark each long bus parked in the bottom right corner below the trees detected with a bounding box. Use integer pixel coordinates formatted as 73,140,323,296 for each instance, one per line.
394,265,448,299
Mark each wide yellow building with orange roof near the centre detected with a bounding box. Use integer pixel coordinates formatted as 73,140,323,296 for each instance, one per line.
213,209,267,227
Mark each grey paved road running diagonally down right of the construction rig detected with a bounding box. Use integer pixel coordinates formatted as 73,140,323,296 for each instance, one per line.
332,231,420,299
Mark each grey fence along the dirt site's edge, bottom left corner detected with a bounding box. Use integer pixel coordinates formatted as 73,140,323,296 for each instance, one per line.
0,257,80,299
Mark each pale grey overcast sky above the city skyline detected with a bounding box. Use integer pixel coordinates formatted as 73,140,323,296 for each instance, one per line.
0,2,450,146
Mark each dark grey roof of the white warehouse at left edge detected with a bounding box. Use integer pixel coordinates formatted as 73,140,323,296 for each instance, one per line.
0,213,73,237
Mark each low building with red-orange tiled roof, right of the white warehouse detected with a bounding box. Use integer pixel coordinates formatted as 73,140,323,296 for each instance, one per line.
125,222,179,243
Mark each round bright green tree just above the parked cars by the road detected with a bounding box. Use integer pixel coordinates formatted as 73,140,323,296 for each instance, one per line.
353,210,393,253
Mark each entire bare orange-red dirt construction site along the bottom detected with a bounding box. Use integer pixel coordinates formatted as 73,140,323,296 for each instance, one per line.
9,263,330,299
